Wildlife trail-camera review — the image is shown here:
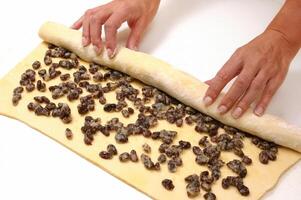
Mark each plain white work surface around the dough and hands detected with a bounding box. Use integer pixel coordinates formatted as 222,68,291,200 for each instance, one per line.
0,0,301,200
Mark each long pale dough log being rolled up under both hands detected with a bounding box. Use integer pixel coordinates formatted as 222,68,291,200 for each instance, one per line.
39,22,301,152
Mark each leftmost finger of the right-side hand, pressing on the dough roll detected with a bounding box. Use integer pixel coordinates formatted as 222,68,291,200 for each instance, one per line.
203,54,242,106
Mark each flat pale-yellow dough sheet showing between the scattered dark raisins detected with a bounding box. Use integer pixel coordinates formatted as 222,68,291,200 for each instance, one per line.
0,43,301,200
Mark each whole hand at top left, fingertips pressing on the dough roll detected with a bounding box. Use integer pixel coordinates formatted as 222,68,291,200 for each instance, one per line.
72,0,160,58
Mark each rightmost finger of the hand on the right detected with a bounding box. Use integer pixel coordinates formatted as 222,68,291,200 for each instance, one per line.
254,77,283,116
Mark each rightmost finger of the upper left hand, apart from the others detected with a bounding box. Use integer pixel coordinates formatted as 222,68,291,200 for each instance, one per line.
126,20,147,51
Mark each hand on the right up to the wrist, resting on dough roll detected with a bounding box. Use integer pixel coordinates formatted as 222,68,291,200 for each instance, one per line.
204,30,298,119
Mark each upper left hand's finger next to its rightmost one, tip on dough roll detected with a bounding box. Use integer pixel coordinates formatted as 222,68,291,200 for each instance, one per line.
104,13,126,58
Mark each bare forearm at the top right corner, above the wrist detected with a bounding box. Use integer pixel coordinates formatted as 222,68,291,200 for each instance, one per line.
267,0,301,50
